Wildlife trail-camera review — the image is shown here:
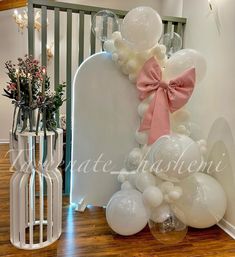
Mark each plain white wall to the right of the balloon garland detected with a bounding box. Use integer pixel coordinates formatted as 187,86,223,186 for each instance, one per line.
183,0,235,230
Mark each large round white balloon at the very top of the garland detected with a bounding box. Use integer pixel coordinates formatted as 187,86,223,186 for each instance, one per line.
121,6,162,51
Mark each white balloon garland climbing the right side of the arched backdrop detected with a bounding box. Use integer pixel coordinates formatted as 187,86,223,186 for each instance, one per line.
96,7,226,243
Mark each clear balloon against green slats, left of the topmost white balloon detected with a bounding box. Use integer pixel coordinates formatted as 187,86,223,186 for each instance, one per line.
91,10,119,42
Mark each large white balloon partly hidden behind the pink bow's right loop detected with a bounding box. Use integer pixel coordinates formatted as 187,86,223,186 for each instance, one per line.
164,49,206,82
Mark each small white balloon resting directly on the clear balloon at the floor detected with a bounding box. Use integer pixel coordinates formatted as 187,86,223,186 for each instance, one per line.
150,203,171,223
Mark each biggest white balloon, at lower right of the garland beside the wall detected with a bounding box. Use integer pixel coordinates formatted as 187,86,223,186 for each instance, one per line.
171,173,227,228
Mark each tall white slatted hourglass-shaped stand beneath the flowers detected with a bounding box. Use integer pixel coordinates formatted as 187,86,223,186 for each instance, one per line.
10,129,63,250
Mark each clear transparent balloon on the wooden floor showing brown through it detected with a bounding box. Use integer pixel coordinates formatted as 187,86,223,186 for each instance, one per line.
148,210,188,245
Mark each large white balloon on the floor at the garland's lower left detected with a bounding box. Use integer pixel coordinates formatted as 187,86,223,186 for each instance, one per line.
106,189,149,236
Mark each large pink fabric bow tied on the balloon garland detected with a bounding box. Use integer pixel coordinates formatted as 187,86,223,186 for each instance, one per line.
137,57,195,144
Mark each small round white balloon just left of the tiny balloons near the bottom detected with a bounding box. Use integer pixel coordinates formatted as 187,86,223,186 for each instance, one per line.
143,186,163,208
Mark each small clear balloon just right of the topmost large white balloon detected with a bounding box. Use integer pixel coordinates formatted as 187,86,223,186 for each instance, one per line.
160,32,182,57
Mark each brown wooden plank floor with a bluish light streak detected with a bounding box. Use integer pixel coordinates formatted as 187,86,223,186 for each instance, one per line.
0,145,235,257
